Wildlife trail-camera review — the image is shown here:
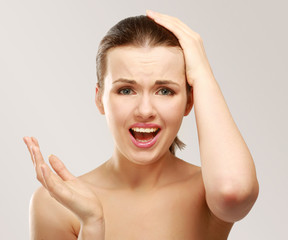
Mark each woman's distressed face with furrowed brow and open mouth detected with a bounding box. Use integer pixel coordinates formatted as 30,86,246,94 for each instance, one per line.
96,46,192,165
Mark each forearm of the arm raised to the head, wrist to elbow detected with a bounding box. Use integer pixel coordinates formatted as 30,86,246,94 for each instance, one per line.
193,75,258,219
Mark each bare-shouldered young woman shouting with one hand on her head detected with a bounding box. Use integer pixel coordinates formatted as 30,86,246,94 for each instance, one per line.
24,11,258,240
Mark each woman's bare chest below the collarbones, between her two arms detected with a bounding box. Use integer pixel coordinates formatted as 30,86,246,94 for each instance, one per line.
103,183,209,240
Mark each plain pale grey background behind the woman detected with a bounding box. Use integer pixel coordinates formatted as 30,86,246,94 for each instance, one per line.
0,0,288,240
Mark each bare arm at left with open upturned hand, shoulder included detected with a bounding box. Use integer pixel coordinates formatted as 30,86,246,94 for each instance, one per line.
24,137,105,240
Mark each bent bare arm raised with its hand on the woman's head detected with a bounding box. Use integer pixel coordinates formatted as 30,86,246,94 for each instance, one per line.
147,12,258,222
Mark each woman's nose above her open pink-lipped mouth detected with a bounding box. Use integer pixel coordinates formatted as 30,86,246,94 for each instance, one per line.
135,94,156,121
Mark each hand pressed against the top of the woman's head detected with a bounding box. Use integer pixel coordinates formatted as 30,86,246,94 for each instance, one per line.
147,10,213,86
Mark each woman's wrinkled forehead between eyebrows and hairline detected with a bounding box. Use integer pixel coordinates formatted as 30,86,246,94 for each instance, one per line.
107,46,185,80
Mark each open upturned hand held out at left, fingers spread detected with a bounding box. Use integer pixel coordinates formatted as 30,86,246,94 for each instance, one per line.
23,137,103,225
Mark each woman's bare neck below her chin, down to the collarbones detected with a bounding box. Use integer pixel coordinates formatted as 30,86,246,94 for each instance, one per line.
106,150,176,190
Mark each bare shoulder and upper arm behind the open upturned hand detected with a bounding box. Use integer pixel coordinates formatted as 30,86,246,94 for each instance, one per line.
30,187,77,240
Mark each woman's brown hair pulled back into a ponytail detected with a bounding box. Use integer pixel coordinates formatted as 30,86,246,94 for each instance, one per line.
96,16,190,155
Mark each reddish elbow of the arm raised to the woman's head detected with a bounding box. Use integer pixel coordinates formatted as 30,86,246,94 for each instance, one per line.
207,179,259,222
